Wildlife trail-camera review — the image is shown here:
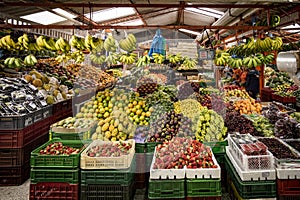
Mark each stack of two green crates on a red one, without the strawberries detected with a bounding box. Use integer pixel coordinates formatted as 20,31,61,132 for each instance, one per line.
30,139,87,200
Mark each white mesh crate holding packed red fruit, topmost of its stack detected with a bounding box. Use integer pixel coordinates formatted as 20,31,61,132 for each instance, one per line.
228,133,274,171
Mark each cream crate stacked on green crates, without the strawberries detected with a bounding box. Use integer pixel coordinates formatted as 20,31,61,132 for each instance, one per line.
80,140,136,200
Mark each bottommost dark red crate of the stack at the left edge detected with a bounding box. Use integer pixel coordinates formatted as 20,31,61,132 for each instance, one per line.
0,159,30,186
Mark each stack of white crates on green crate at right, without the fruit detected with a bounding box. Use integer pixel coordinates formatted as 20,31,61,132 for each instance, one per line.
225,134,276,199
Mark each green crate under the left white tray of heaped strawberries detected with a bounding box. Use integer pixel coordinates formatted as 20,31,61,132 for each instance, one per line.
148,179,185,199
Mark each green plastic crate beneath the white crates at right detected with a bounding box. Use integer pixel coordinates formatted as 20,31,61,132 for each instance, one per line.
225,155,276,199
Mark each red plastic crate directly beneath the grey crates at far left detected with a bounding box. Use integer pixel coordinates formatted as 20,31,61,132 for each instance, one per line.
0,117,52,149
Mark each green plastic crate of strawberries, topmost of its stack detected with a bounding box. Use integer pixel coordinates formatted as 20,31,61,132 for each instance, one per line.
30,138,87,168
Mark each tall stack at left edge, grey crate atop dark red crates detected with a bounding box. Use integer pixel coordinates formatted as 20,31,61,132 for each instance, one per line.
0,115,52,185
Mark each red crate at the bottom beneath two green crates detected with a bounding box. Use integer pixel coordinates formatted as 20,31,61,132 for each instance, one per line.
29,182,79,200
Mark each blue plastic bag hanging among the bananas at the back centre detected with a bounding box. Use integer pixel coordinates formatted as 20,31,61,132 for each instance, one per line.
148,29,166,56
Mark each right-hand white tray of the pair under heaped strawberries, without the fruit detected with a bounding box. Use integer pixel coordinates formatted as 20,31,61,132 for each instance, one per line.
185,148,221,179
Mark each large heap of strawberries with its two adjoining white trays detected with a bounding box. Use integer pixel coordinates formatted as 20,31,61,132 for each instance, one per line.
150,137,221,179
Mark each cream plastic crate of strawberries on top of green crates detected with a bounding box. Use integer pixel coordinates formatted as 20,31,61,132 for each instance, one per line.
80,139,135,169
